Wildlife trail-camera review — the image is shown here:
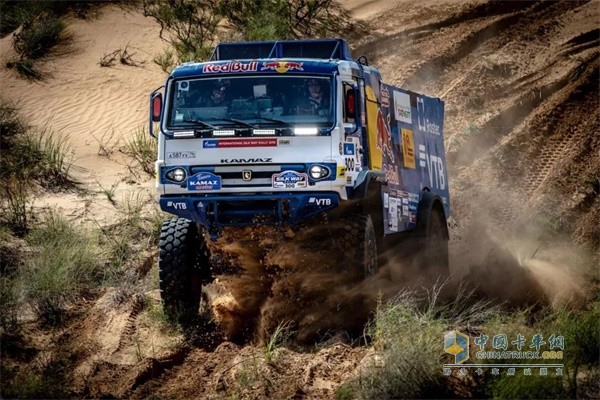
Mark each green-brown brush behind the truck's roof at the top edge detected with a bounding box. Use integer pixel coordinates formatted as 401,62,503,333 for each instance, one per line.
144,0,364,64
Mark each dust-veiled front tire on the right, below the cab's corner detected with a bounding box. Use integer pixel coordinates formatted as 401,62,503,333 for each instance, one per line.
348,213,377,278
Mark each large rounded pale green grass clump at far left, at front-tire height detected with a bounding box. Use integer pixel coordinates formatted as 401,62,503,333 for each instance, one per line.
21,212,103,324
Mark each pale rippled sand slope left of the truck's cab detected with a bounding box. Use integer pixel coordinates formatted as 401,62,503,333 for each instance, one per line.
0,6,165,220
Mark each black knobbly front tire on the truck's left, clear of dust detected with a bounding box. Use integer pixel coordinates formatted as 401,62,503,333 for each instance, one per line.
158,218,210,322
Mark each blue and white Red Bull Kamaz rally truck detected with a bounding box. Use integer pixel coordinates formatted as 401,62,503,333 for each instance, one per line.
149,39,450,320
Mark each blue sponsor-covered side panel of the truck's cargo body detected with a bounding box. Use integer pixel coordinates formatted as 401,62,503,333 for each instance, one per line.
369,83,450,234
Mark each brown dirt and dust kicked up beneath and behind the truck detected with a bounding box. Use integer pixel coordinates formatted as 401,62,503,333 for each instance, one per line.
204,211,589,344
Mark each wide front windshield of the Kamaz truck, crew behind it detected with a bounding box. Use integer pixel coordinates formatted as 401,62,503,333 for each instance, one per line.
167,75,335,129
